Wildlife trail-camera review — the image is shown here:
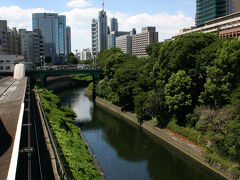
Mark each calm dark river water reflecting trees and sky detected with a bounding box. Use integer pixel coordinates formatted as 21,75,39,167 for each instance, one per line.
59,88,225,180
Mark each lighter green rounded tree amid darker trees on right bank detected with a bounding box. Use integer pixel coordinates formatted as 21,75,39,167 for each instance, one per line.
164,70,193,122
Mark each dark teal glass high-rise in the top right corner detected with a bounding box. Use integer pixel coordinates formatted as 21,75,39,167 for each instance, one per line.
196,0,240,26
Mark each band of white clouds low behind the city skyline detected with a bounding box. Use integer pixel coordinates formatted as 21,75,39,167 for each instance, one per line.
0,6,194,50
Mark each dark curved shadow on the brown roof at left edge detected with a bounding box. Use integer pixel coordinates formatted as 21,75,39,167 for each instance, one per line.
0,118,12,157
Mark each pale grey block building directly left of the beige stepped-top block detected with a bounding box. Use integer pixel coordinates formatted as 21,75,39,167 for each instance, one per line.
116,35,132,54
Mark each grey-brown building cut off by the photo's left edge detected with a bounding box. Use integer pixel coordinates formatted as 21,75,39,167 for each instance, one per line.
0,20,8,55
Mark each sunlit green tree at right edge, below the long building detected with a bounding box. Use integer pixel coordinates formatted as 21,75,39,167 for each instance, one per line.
199,39,240,107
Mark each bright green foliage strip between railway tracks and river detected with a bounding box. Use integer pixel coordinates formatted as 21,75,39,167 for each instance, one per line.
41,90,101,180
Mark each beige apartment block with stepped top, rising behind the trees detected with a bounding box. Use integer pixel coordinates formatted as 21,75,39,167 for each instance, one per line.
132,27,158,57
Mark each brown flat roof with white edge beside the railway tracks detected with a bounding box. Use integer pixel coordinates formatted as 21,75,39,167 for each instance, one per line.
0,77,27,179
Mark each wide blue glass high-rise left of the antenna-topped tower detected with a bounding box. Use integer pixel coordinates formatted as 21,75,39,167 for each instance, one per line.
32,13,67,64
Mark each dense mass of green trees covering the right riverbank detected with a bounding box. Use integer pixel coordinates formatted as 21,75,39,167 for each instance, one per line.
97,33,240,176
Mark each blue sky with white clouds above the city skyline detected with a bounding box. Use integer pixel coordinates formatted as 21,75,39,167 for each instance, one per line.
0,0,196,52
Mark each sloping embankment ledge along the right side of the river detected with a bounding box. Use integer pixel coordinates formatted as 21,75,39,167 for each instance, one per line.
85,89,233,179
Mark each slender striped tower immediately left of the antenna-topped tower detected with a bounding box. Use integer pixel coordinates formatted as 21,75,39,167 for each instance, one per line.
91,19,98,57
